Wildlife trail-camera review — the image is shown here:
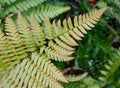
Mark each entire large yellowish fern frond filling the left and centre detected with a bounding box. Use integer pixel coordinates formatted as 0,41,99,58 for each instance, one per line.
0,8,106,88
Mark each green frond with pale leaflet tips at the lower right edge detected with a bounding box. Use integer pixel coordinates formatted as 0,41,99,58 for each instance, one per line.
99,49,120,82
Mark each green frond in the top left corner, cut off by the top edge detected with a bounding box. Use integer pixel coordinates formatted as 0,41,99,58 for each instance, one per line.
2,0,46,17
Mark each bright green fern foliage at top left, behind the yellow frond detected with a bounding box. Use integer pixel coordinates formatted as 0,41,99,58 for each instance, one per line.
0,0,70,22
